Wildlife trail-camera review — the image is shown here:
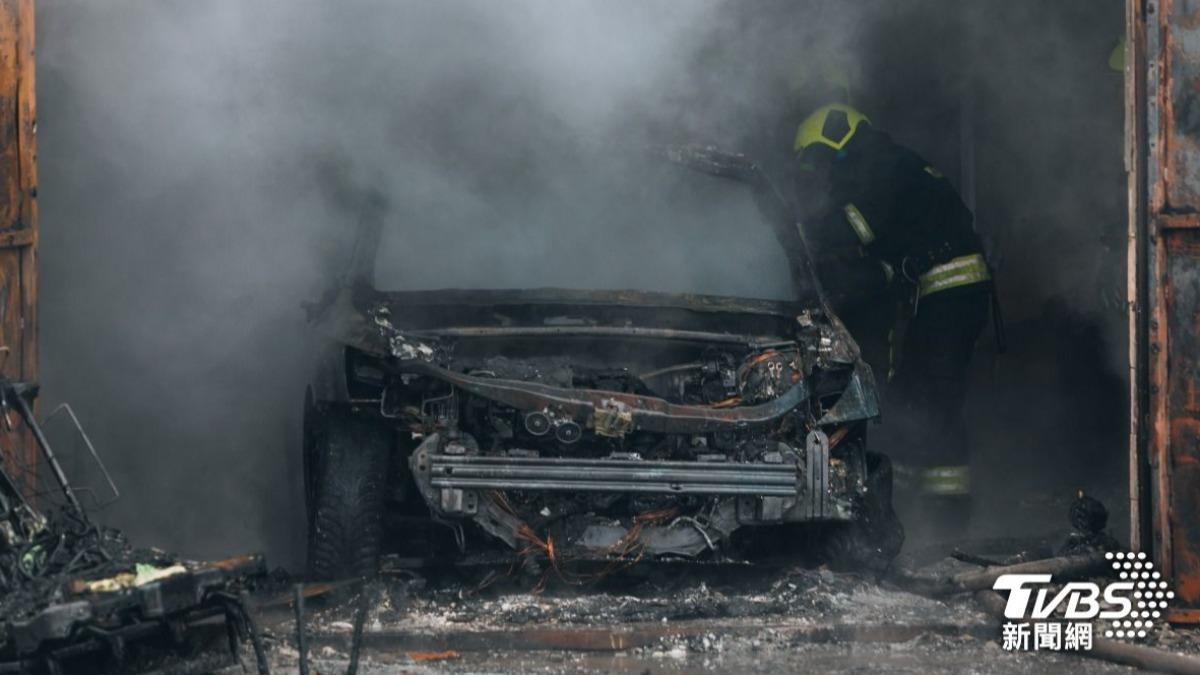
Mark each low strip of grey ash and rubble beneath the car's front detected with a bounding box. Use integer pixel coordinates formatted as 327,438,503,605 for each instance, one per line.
297,567,982,633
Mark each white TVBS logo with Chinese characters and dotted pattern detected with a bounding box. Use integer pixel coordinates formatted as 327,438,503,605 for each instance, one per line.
992,552,1175,650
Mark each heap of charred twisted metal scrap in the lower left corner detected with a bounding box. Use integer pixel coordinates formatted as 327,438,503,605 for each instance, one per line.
0,381,266,674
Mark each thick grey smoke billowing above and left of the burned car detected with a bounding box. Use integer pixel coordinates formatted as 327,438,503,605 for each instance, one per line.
38,0,1120,563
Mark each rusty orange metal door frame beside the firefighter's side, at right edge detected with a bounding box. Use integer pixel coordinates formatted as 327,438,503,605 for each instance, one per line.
1126,0,1200,622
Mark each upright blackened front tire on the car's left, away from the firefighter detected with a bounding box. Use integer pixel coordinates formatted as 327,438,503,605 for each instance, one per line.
305,403,391,579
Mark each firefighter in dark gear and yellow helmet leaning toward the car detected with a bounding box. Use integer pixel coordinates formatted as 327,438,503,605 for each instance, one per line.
794,103,994,536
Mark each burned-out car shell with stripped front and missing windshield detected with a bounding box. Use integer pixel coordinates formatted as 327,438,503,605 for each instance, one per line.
304,148,902,578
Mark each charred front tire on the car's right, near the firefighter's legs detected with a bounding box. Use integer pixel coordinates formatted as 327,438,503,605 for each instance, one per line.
823,452,904,574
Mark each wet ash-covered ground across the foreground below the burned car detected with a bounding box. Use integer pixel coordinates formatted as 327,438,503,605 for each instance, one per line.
231,562,1200,674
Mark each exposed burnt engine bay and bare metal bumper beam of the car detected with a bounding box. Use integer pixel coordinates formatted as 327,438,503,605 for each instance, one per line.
333,300,877,561
